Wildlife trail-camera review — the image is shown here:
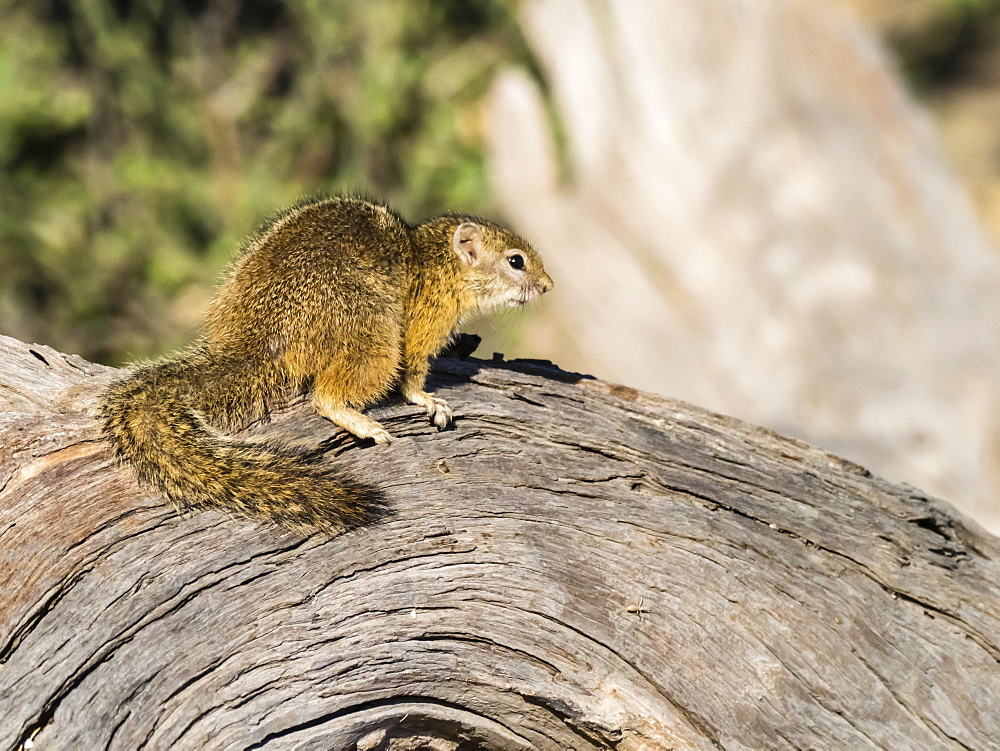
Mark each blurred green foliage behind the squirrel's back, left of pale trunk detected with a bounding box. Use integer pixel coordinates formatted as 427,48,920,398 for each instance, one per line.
0,0,531,363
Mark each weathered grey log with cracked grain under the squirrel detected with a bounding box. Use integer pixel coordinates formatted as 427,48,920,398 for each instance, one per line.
0,339,1000,749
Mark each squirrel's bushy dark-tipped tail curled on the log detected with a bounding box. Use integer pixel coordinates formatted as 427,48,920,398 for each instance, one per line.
103,360,383,534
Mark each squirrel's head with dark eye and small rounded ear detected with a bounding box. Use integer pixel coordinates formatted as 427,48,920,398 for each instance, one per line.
452,220,552,310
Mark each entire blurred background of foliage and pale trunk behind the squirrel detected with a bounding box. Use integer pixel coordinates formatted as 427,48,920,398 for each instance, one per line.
0,0,1000,532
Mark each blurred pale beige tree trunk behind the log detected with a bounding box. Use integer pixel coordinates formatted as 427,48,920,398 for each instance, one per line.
486,0,1000,531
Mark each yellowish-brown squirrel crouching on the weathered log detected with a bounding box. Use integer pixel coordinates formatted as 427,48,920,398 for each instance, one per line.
102,197,552,533
